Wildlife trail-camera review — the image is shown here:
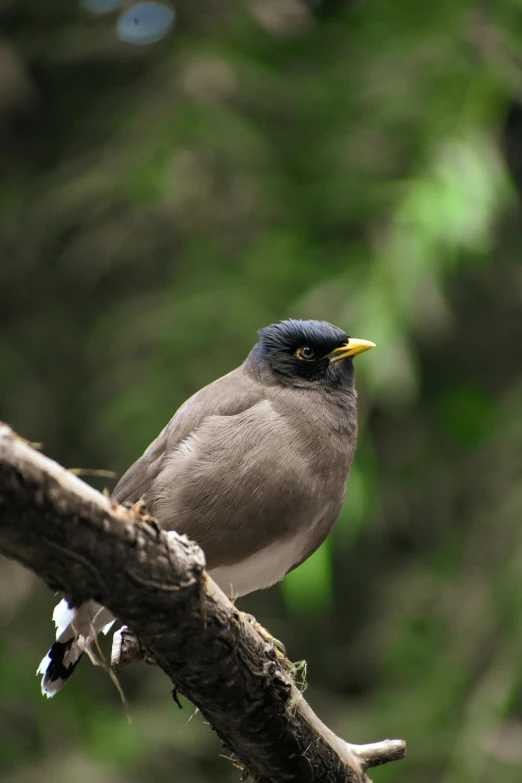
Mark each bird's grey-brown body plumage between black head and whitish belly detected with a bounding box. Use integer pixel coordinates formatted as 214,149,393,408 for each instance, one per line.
114,367,357,570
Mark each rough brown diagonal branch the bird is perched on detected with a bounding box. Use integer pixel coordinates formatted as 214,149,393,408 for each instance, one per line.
0,424,406,783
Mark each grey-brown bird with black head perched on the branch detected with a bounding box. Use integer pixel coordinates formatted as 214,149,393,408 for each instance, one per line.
37,319,375,697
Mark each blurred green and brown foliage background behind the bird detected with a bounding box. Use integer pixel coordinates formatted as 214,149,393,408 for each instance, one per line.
0,0,522,783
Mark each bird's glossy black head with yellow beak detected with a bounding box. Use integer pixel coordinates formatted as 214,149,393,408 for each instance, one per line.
247,320,375,388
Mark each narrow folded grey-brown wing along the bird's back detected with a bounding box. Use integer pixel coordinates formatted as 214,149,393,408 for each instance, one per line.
112,366,262,505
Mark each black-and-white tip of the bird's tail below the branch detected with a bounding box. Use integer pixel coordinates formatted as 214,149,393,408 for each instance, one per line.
36,598,115,698
